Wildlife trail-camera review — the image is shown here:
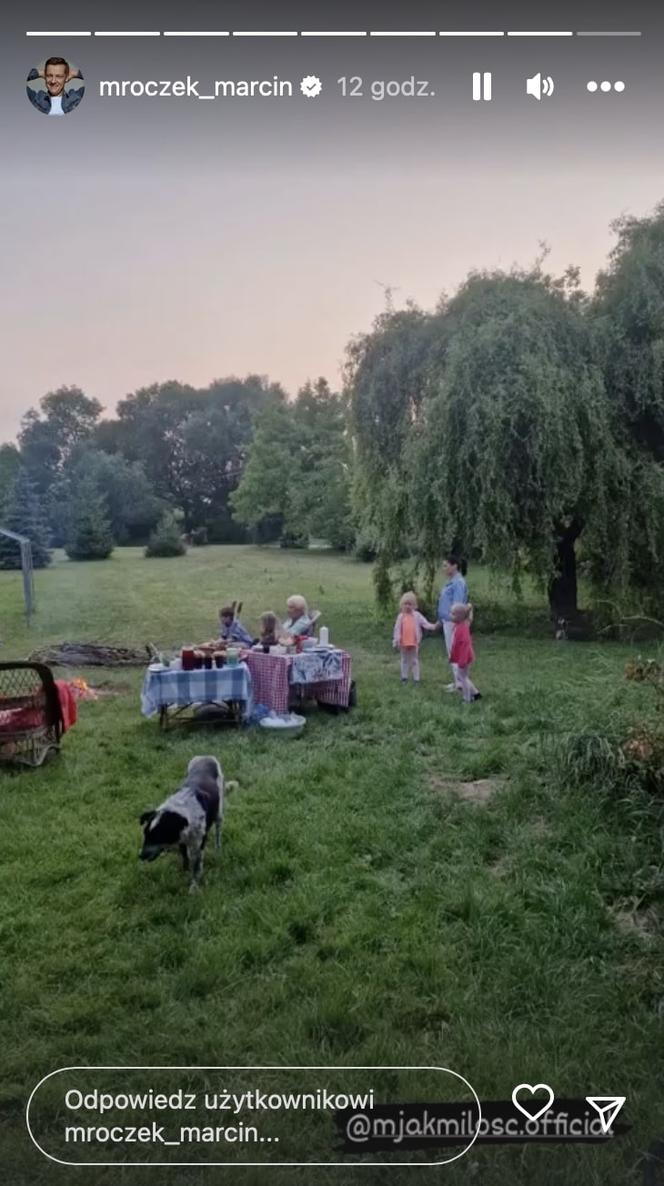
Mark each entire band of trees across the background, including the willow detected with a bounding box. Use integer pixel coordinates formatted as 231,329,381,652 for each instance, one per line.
0,203,664,617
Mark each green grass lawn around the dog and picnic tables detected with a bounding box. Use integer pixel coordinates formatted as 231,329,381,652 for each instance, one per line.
0,547,664,1186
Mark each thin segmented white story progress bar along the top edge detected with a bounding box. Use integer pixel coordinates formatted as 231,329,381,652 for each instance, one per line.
25,28,643,37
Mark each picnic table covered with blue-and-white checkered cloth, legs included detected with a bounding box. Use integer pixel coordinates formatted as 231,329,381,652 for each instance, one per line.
141,661,253,728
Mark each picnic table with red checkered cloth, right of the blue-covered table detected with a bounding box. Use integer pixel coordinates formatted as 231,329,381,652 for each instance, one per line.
244,648,352,713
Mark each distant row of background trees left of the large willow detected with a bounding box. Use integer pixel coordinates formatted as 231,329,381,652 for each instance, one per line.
0,376,352,568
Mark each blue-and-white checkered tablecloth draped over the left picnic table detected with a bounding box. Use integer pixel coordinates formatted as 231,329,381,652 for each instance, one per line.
141,663,251,718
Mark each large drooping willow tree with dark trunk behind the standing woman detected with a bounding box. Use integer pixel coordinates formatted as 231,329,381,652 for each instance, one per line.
350,269,633,618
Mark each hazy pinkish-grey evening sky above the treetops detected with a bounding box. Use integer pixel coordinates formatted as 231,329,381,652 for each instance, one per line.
0,0,664,440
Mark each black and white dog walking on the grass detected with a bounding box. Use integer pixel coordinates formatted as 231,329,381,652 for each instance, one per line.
139,757,236,890
